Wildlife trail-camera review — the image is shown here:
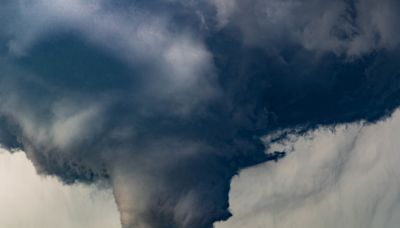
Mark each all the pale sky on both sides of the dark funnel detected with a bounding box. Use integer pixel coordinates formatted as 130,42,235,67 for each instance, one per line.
0,108,400,228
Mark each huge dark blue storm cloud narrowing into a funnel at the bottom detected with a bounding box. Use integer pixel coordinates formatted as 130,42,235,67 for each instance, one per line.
0,0,400,228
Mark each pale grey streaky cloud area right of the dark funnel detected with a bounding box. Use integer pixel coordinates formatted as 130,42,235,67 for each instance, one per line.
216,111,400,228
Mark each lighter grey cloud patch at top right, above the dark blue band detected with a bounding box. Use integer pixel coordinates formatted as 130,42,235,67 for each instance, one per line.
213,0,400,57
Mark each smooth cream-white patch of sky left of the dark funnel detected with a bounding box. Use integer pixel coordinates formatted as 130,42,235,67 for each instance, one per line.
0,150,121,228
